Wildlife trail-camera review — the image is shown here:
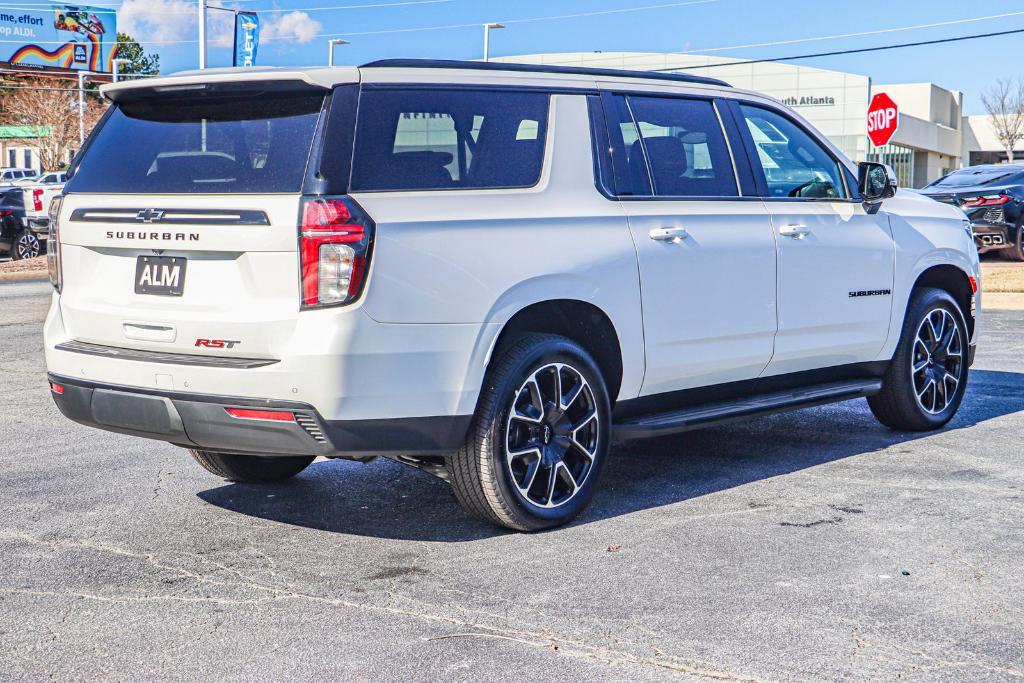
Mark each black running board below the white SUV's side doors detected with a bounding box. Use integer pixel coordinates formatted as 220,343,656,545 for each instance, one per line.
613,379,882,440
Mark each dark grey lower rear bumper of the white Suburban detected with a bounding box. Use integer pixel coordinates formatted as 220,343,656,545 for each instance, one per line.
47,374,471,458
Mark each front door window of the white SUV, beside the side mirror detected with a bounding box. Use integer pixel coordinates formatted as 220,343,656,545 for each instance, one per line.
740,104,847,200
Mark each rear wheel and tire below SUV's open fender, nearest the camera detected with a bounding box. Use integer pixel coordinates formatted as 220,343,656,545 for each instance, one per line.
447,334,611,531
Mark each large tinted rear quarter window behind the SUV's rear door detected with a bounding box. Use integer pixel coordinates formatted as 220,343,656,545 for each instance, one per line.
352,90,548,191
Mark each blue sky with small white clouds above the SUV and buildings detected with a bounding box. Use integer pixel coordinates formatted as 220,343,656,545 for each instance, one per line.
119,0,1024,114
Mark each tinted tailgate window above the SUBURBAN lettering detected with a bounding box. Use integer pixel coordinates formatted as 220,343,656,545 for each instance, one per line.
68,93,324,195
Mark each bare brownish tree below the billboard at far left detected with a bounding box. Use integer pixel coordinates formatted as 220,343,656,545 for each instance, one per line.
2,79,106,171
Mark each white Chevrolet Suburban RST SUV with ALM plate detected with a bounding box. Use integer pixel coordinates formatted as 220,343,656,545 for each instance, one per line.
45,60,980,530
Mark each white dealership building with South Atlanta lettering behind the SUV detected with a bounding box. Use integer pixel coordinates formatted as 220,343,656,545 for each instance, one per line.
493,52,1006,187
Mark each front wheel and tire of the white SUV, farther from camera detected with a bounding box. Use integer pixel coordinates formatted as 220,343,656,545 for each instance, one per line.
867,288,970,432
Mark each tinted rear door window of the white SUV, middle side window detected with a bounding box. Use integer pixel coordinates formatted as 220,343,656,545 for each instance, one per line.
624,97,738,197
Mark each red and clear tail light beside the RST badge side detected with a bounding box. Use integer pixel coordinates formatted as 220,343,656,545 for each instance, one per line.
299,197,374,307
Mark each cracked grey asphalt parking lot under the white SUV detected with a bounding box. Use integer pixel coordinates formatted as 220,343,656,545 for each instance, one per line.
0,283,1024,681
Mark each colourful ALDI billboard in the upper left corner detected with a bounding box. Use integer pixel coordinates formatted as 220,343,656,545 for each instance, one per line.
0,4,118,73
